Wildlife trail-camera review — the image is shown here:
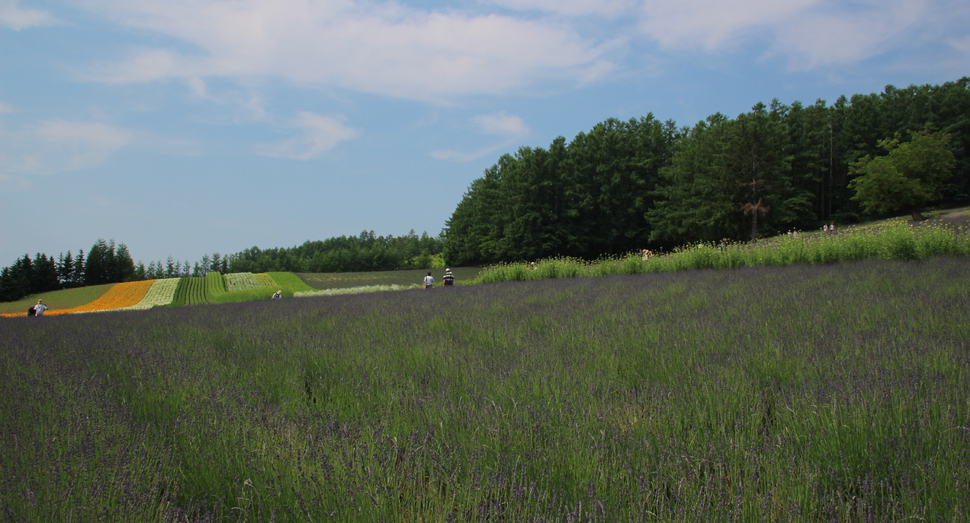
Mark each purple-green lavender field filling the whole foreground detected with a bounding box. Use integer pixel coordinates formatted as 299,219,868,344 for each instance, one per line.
0,257,970,522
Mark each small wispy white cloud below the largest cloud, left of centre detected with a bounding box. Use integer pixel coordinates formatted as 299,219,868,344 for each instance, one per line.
256,111,357,160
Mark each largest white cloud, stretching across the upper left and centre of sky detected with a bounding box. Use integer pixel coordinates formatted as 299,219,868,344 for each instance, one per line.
81,0,612,100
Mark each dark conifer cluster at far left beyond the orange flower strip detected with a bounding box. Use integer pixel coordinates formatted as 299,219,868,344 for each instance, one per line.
0,239,138,301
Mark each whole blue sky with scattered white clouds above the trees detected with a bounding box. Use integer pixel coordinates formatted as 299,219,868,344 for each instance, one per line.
0,0,970,266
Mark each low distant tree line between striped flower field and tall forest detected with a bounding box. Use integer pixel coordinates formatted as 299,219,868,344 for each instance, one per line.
220,230,444,272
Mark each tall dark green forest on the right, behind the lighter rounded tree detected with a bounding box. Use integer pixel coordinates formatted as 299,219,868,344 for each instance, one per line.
443,77,970,265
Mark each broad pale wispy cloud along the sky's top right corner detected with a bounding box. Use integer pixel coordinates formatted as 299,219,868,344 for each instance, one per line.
639,0,956,70
